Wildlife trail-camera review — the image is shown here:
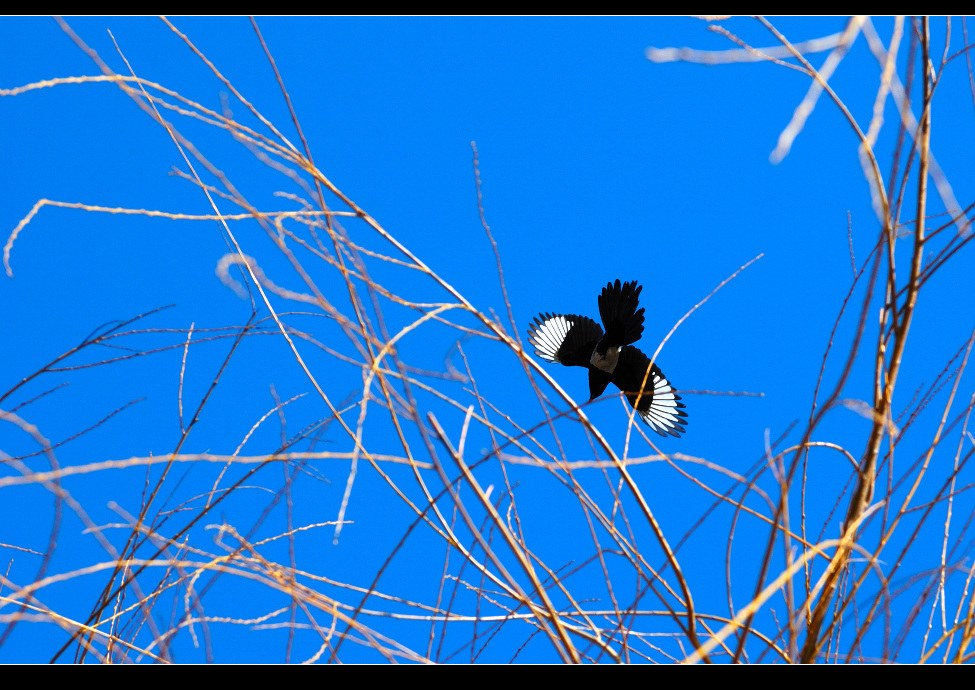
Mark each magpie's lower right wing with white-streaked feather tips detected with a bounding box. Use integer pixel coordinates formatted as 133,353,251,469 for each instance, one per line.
613,345,687,436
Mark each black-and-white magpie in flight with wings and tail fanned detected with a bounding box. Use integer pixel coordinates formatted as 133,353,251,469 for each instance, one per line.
528,279,687,436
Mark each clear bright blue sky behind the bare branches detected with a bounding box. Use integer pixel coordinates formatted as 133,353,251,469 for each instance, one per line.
0,16,975,663
